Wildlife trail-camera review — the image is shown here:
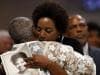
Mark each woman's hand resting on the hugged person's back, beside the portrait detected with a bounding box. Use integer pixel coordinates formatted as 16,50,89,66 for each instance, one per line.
25,54,50,68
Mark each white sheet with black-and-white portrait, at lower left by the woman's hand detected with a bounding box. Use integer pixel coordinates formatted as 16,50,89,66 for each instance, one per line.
1,43,39,75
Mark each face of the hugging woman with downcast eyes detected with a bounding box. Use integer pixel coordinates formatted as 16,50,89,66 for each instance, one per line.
36,17,59,41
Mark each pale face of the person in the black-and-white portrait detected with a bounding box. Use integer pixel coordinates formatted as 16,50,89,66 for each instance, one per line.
15,57,26,72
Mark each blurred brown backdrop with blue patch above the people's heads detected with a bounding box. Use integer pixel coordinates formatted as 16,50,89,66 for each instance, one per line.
0,0,100,29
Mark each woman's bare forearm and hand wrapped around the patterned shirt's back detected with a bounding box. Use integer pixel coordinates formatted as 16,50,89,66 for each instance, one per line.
24,55,67,75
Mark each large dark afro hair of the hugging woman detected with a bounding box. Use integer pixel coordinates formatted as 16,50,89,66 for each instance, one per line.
32,2,68,33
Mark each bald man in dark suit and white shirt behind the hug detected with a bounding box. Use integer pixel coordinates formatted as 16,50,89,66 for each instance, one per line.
64,15,100,75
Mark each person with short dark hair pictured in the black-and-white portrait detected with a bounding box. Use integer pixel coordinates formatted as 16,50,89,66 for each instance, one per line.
11,52,38,75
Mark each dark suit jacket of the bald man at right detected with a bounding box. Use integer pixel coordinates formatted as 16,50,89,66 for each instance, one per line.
89,47,100,75
